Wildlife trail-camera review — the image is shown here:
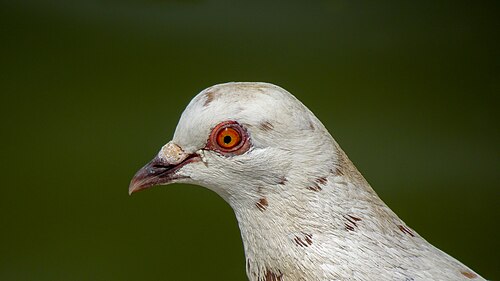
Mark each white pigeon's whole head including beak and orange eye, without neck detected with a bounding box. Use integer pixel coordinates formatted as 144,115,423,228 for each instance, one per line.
129,82,335,203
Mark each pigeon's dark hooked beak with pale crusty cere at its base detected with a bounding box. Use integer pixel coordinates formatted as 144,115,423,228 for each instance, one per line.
128,142,200,194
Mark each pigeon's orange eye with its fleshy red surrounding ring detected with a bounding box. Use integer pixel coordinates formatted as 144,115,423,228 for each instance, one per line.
207,121,250,155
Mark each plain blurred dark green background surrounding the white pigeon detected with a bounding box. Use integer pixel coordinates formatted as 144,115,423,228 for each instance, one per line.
0,0,500,280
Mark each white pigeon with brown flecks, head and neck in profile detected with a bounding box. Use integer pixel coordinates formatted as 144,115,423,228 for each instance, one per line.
129,82,485,281
